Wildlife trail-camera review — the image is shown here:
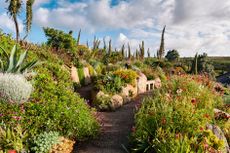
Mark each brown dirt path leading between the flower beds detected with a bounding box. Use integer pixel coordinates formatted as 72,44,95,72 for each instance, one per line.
75,95,148,153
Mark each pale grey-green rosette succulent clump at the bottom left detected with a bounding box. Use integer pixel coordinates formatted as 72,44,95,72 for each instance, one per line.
31,132,59,153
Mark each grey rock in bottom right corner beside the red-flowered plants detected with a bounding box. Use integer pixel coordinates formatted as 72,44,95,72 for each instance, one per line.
207,124,230,153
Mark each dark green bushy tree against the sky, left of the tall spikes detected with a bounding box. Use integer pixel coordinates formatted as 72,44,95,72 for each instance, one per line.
43,28,76,56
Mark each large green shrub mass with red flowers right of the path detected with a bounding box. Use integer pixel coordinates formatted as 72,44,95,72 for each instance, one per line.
132,76,226,152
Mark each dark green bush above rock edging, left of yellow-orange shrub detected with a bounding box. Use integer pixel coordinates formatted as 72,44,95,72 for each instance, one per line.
94,73,124,94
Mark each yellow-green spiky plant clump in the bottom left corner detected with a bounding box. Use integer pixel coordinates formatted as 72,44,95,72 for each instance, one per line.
0,124,27,152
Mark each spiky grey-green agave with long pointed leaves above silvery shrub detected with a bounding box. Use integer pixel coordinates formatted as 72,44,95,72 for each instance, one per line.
0,45,38,73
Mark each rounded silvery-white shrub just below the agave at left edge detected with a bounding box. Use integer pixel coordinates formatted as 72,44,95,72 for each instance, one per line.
0,73,33,104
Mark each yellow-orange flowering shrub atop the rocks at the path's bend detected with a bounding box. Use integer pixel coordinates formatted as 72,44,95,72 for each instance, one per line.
113,69,137,86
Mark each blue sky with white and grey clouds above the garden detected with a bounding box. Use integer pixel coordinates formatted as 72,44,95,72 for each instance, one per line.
0,0,230,56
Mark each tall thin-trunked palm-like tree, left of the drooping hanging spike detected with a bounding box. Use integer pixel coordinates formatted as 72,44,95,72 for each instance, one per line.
6,0,22,42
